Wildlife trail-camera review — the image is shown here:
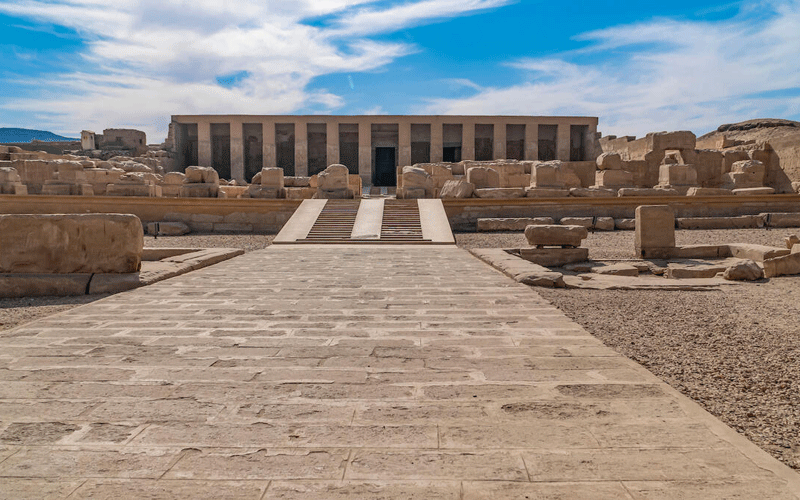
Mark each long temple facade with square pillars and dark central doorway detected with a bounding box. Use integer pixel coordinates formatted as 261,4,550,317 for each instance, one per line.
171,115,600,186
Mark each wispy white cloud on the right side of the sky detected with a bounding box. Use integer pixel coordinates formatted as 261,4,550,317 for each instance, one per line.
418,0,800,135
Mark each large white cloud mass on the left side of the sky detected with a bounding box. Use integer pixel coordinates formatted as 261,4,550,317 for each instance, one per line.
0,0,508,142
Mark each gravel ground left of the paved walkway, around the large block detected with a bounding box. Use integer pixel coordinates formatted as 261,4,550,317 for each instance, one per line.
0,234,275,331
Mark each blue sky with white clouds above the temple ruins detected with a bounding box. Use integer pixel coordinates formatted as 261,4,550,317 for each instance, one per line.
0,0,800,143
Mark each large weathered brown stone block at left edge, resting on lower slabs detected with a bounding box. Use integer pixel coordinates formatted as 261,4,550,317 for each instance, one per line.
0,214,144,274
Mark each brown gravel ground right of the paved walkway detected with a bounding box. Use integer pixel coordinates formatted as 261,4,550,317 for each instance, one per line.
456,229,800,469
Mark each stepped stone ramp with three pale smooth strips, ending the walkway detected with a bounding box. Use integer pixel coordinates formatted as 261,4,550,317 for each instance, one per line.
273,199,455,245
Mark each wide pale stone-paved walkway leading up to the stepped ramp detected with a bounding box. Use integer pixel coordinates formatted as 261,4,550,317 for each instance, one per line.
0,245,800,500
